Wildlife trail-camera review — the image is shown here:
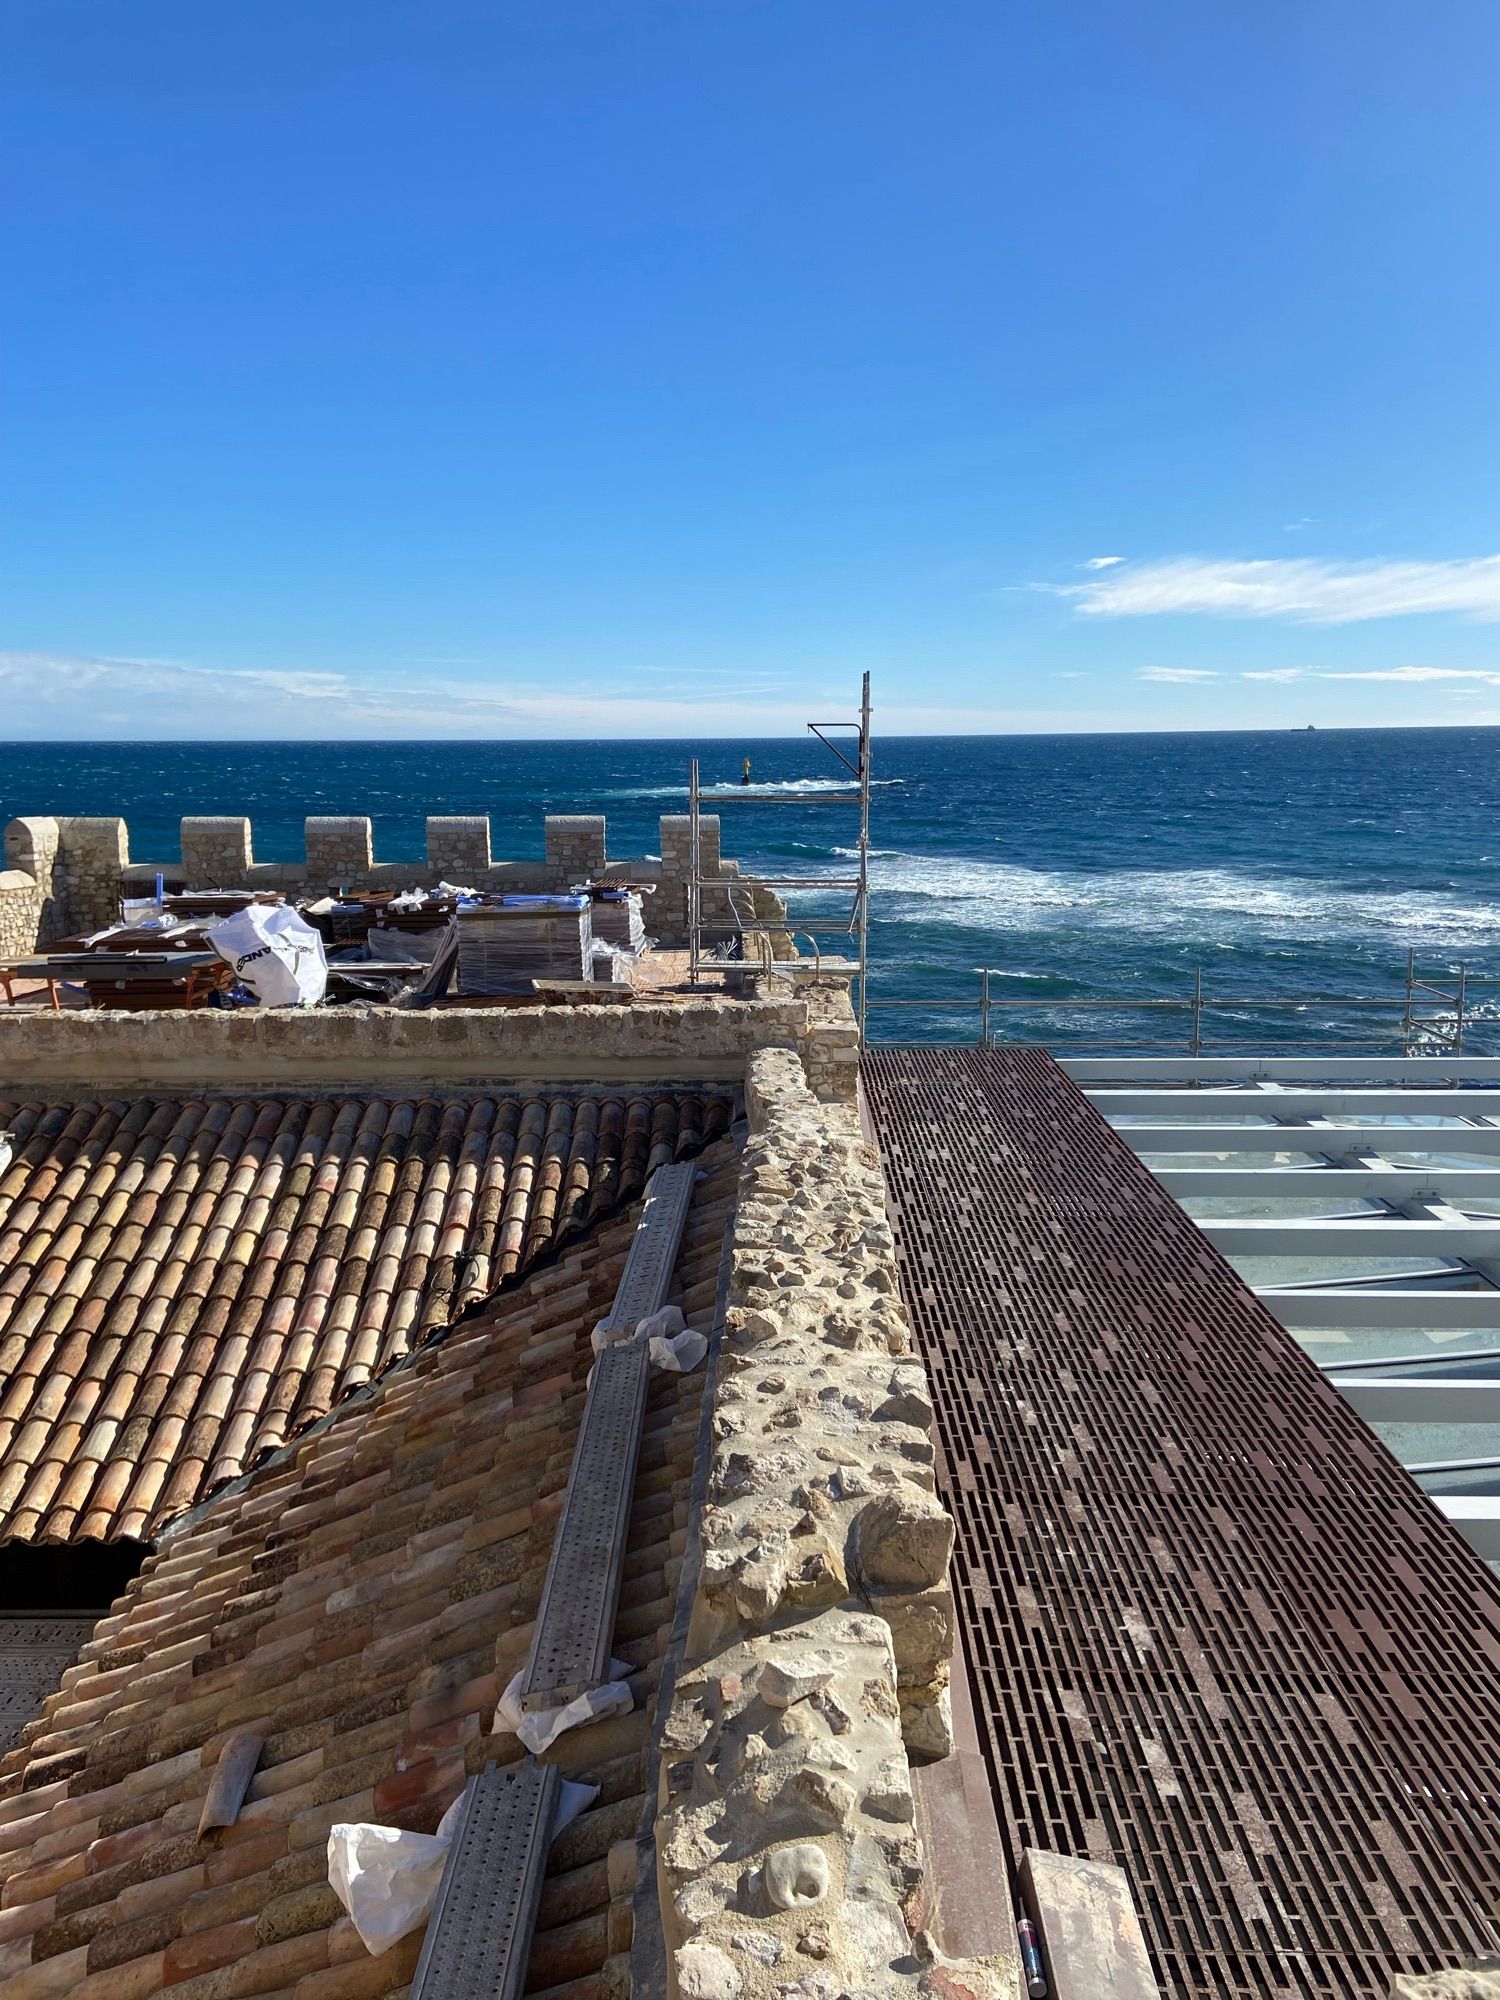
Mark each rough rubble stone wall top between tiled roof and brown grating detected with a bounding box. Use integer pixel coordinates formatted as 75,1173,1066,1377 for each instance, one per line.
656,1050,1000,2000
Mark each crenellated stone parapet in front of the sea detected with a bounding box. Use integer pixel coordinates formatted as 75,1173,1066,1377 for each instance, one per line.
0,812,794,958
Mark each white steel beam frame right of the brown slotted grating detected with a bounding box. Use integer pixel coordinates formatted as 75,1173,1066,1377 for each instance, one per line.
1096,1054,1500,1562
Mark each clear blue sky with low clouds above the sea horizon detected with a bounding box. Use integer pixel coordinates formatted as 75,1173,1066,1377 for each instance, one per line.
0,0,1500,736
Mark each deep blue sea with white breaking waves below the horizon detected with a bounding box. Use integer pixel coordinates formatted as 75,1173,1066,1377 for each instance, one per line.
0,728,1500,1052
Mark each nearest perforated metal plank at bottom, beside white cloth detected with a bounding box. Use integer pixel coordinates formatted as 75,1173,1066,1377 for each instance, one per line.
412,1756,562,2000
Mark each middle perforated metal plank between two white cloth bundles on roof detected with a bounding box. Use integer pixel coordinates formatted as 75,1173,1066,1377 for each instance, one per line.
522,1340,650,1708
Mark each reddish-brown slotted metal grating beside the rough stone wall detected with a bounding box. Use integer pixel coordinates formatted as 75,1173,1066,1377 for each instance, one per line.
864,1048,1500,2000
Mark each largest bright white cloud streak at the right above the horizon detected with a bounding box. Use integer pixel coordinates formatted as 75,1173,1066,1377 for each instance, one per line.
1042,556,1500,624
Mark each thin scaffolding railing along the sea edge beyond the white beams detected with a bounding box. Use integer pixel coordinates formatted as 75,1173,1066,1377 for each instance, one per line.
866,952,1500,1056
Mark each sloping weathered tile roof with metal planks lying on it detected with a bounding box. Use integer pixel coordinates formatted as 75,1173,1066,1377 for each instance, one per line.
0,1142,738,2000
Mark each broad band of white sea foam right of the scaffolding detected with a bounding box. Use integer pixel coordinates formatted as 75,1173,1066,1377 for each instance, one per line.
792,850,1500,948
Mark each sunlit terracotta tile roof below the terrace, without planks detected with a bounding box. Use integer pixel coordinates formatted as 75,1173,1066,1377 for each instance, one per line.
0,1094,732,1542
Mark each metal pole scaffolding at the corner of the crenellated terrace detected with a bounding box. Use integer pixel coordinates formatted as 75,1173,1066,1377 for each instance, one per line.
688,674,870,1042
